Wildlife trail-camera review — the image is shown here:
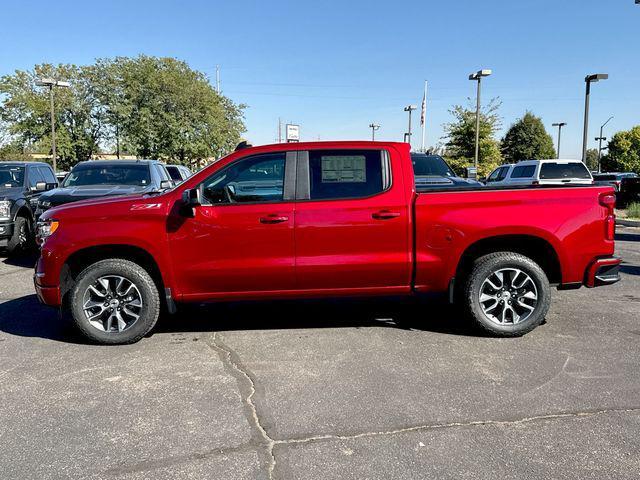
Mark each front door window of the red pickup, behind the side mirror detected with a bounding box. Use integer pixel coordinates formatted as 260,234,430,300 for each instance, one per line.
202,153,286,205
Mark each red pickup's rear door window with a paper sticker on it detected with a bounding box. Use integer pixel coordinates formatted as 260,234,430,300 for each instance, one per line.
309,150,390,200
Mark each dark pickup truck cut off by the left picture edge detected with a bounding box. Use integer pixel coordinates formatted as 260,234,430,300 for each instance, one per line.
0,162,58,255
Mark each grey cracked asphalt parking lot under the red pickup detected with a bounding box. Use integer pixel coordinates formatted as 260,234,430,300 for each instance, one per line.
0,228,640,480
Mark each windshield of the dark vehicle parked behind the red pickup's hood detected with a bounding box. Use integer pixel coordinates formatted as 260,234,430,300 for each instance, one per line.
62,164,151,187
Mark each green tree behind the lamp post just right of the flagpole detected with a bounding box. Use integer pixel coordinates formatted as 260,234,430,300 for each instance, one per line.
444,98,502,176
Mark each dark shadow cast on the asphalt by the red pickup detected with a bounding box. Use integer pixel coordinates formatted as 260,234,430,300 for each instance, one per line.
0,295,479,344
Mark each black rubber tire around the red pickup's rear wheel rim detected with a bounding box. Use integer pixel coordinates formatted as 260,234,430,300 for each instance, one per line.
462,252,551,337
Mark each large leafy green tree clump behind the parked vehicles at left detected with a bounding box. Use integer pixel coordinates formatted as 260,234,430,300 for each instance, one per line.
0,56,245,168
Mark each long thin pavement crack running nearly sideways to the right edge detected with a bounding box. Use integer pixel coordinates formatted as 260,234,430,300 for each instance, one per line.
274,407,640,445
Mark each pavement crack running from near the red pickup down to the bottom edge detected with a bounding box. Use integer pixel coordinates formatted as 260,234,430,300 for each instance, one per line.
207,332,276,479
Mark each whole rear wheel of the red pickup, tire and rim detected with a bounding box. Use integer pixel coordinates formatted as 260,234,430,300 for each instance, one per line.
464,252,551,337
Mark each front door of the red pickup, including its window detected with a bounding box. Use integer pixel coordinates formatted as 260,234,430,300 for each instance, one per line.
169,152,295,300
